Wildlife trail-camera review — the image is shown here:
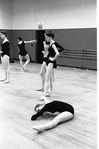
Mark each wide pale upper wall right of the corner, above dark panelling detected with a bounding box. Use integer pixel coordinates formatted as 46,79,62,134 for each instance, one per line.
13,0,96,29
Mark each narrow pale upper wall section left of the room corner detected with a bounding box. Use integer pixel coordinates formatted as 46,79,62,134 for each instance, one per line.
0,0,13,29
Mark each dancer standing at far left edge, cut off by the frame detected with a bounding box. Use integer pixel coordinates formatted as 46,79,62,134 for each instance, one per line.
0,31,10,84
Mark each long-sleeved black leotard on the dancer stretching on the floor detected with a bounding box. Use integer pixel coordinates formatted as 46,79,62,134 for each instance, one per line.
31,101,74,120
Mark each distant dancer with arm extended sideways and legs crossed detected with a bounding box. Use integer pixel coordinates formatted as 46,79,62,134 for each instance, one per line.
17,37,37,71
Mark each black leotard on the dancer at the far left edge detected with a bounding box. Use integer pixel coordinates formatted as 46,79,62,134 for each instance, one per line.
1,41,10,57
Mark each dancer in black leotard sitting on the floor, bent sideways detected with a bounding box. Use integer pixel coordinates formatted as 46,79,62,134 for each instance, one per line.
31,97,74,132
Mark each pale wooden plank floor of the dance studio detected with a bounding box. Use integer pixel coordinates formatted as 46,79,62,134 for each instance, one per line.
0,62,97,149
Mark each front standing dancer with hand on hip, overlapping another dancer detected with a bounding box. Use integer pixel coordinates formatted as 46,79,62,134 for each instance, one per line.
40,31,59,100
